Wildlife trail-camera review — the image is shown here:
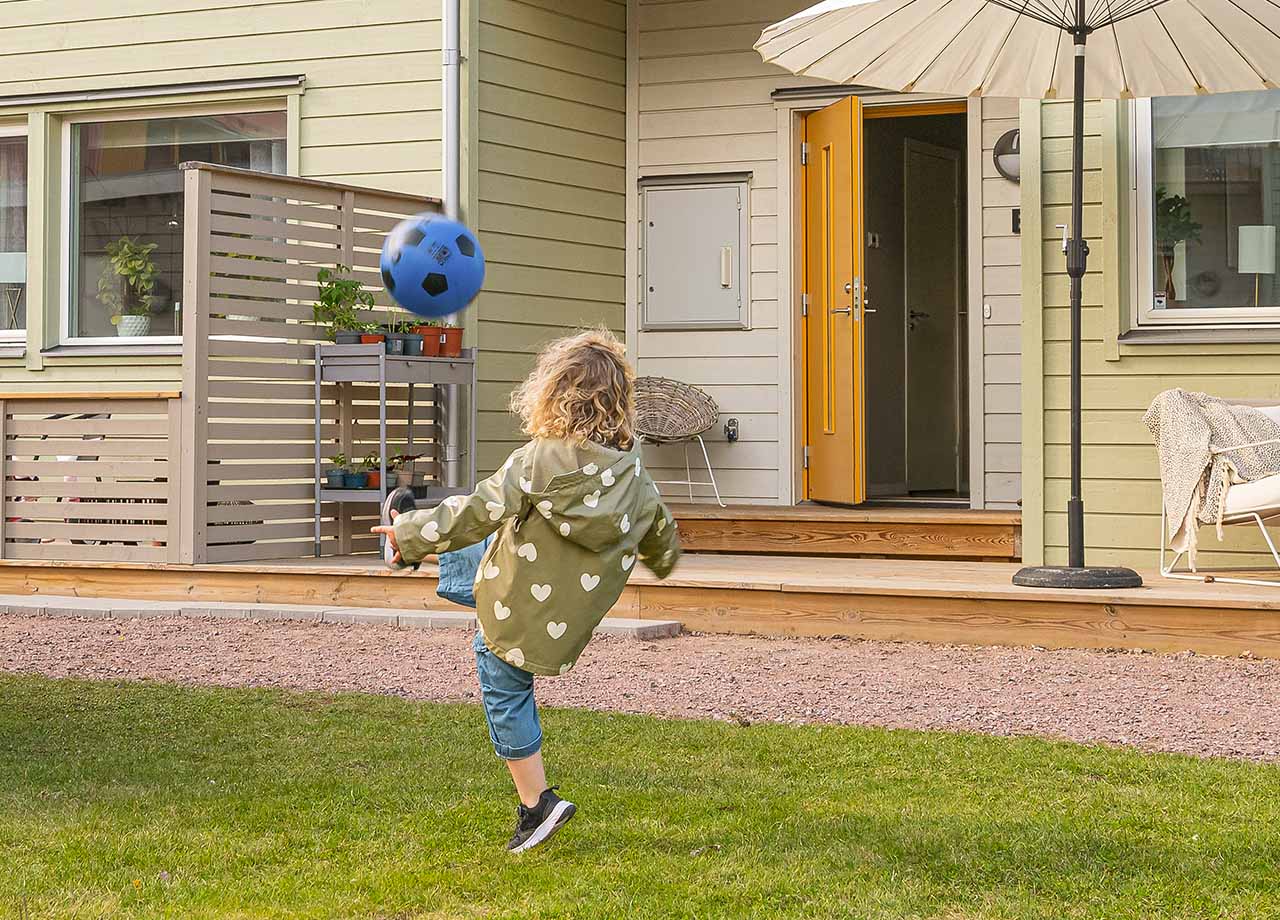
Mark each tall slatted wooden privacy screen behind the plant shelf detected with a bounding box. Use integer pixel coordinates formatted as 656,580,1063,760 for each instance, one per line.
182,164,439,563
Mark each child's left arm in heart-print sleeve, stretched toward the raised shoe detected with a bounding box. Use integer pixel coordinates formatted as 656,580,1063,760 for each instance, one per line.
372,448,525,564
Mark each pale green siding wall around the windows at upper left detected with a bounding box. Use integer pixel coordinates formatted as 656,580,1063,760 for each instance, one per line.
0,0,440,390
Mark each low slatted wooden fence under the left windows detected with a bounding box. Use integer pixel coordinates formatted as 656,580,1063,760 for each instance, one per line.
0,397,182,562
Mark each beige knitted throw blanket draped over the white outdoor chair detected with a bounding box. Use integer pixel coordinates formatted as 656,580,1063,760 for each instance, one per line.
1142,389,1280,571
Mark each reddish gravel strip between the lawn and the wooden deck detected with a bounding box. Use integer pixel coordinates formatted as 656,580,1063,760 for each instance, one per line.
0,615,1280,761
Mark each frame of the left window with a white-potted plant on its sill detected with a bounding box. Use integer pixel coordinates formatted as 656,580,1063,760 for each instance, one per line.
58,96,292,348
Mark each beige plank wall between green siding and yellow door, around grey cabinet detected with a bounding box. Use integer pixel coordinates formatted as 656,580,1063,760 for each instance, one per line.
632,0,813,503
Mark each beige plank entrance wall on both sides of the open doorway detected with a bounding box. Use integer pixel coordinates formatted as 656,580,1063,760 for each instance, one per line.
628,0,1019,507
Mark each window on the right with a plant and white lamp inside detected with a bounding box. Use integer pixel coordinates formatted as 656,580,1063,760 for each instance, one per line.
1134,91,1280,325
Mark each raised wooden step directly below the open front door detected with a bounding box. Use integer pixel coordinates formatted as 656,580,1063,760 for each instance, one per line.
671,504,1021,562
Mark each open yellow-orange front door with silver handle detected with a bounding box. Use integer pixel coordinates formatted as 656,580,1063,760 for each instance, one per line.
804,97,867,504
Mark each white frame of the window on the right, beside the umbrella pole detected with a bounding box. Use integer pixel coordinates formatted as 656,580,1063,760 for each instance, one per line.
1128,99,1280,330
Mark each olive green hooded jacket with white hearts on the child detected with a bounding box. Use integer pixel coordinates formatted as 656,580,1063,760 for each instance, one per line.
396,439,680,674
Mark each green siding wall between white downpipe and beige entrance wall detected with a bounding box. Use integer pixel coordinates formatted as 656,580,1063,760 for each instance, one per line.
474,0,626,471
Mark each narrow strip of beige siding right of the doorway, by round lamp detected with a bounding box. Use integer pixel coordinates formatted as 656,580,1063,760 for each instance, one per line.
969,99,1023,509
